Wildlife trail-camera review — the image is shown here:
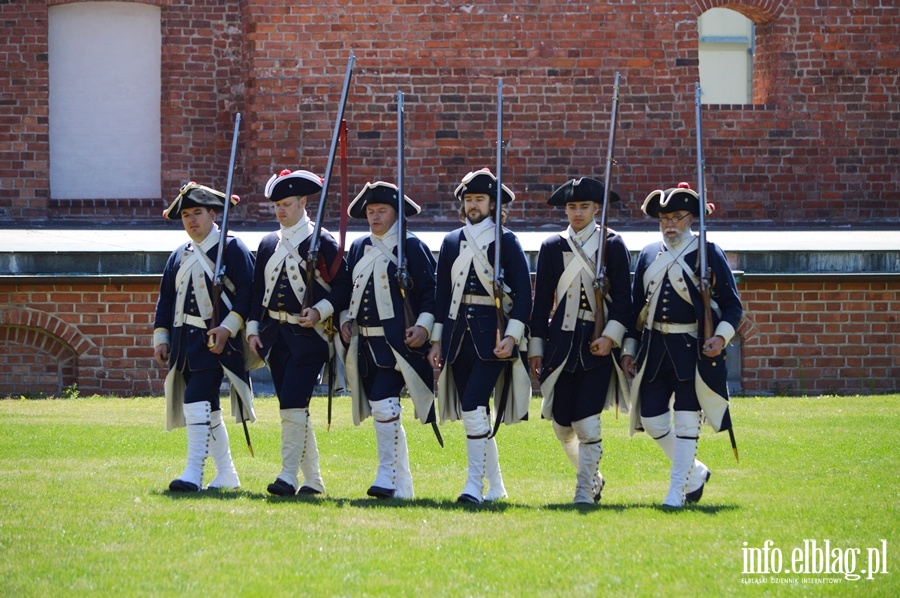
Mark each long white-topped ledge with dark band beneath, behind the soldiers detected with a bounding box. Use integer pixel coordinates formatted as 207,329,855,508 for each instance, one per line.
0,229,900,282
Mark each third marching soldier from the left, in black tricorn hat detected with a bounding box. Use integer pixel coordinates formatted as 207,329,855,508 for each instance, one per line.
341,181,435,499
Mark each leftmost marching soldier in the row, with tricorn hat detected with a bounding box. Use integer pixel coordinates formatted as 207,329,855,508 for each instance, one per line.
153,182,256,492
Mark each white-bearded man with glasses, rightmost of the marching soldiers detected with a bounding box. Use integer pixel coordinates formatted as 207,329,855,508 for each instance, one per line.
621,183,743,508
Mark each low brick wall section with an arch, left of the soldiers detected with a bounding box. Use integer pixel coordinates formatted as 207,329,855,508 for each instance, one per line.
0,282,164,396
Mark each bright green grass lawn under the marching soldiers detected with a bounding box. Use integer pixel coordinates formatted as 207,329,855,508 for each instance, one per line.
0,395,900,597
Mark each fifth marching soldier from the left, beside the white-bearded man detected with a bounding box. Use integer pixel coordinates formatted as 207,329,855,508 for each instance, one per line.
528,177,631,504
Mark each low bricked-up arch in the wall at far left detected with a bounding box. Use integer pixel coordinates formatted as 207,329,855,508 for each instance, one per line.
0,307,96,396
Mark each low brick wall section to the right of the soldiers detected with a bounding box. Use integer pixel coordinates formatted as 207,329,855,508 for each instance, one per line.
739,281,900,395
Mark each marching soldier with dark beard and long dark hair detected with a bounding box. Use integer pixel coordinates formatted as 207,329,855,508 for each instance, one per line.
429,168,531,503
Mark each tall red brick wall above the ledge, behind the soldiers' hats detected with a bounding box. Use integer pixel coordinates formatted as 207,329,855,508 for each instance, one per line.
0,0,900,229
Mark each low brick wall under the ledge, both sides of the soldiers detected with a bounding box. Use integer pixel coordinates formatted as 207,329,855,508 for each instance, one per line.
0,281,900,396
